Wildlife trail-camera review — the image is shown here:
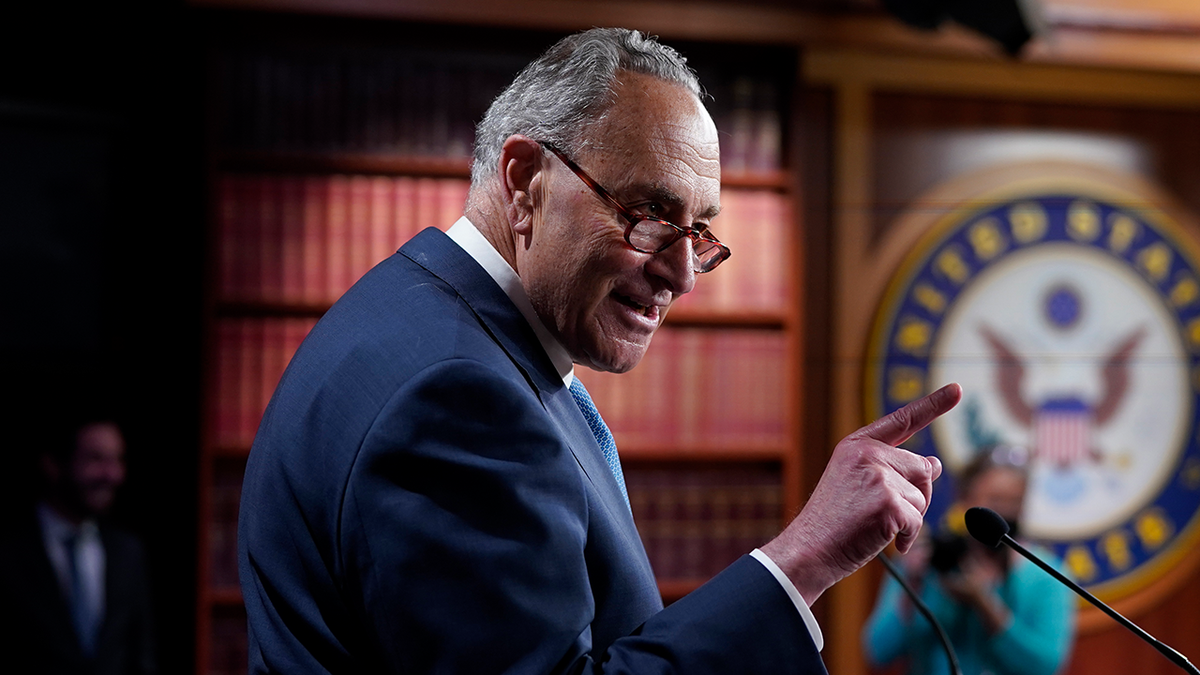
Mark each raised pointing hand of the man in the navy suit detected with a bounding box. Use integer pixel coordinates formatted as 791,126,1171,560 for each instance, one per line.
762,384,962,604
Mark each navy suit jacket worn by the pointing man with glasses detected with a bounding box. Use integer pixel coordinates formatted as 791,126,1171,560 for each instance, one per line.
239,229,824,674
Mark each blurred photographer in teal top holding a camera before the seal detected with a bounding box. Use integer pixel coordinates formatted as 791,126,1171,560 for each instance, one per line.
863,446,1075,675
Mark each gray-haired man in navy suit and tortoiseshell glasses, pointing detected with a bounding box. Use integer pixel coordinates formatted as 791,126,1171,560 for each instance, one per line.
239,29,960,674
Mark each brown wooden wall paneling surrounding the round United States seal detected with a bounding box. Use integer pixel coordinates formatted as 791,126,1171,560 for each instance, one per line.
804,50,1200,675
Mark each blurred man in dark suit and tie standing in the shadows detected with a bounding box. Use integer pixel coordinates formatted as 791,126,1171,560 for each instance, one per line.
0,403,155,675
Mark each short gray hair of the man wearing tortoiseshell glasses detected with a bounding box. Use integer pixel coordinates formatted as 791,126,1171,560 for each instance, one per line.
472,28,702,186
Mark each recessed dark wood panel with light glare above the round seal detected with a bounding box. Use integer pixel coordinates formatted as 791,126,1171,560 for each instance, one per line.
871,92,1200,239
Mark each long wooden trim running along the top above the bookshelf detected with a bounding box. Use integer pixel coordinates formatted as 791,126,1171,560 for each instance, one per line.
187,0,1200,73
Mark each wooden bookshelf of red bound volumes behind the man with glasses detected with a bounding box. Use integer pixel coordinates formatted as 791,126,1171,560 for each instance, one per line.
197,13,802,675
